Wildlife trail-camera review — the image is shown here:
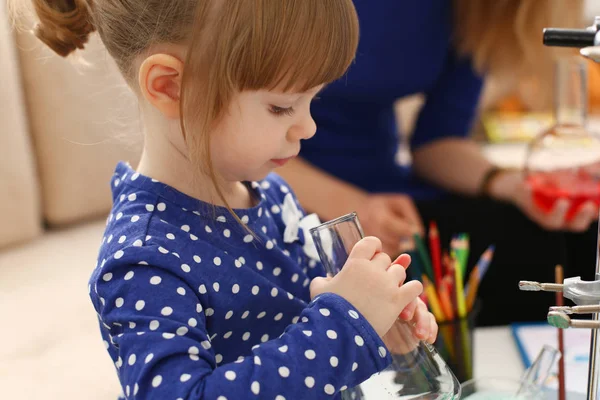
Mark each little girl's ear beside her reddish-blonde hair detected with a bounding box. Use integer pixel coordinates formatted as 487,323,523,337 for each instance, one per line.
138,54,183,119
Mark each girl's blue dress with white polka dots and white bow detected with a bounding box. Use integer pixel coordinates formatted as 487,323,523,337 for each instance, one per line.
89,163,391,400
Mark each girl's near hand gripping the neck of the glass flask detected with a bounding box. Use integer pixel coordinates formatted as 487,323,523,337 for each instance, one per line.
310,237,423,337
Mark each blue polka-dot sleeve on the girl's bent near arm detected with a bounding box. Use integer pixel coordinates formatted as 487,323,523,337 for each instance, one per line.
92,265,391,400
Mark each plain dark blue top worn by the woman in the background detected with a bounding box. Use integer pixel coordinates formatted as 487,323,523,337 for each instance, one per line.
300,0,482,199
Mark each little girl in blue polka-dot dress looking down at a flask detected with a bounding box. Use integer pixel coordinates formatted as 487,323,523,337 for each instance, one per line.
17,0,437,400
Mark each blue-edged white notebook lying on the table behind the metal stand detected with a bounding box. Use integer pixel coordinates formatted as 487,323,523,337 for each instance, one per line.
511,322,591,393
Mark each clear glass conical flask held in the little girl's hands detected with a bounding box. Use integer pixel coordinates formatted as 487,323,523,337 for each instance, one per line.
310,213,460,400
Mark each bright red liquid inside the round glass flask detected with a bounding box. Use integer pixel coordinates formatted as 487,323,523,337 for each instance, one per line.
527,170,600,220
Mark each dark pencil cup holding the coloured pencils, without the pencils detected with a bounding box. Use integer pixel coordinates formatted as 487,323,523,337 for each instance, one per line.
434,303,479,382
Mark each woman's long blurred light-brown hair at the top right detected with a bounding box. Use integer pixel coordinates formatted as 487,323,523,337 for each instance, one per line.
453,0,585,108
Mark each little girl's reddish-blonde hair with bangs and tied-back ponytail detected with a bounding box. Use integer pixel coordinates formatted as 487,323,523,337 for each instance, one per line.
14,0,358,225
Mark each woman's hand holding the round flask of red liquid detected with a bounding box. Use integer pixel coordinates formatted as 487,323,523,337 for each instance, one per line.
490,171,598,232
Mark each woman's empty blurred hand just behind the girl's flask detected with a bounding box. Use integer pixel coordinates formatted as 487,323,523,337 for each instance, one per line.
356,194,424,256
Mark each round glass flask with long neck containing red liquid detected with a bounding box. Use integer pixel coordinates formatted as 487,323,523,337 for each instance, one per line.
525,57,600,220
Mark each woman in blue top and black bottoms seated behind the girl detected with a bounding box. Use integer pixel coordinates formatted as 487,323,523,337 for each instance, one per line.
281,0,597,324
